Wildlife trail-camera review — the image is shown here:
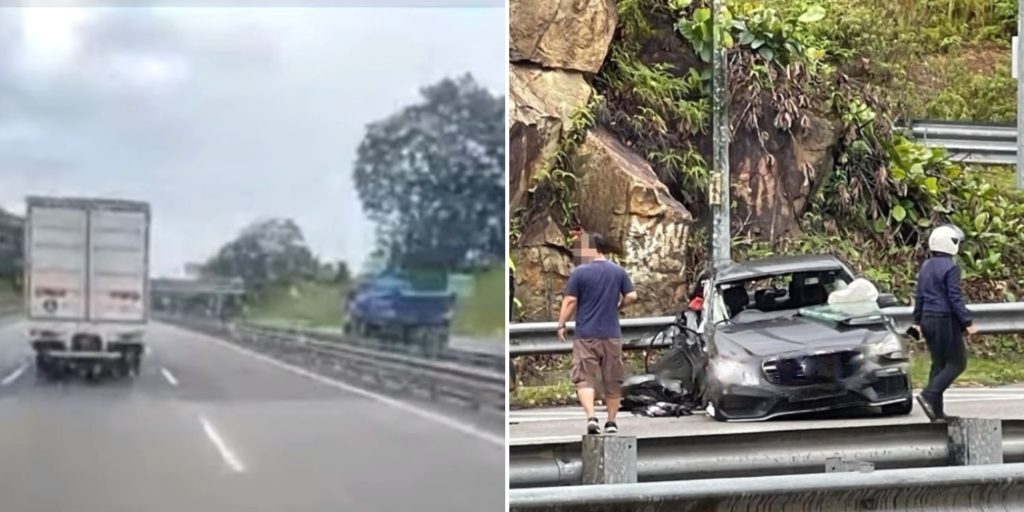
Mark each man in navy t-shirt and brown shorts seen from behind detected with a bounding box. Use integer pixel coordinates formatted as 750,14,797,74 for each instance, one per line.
558,233,637,434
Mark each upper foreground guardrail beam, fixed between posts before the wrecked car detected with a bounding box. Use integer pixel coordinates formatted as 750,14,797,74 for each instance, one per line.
509,420,1024,485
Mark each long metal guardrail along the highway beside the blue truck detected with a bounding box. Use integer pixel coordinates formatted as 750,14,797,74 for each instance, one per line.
158,316,506,413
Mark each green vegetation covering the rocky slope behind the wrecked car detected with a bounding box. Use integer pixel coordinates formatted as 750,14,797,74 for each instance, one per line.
596,0,1024,315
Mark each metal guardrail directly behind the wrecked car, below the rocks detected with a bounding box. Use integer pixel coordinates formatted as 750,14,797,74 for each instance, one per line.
509,302,1024,356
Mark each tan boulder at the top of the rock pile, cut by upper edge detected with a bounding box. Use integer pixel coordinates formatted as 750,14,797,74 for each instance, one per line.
509,0,618,74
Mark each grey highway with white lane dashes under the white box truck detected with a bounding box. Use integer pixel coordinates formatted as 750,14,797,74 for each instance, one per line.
0,319,505,512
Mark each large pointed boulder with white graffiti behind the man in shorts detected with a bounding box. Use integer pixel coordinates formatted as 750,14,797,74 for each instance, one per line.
577,128,693,315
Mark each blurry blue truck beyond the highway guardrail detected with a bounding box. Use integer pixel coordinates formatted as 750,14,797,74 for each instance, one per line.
344,271,456,357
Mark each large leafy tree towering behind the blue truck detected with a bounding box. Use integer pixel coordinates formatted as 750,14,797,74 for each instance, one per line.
353,75,505,268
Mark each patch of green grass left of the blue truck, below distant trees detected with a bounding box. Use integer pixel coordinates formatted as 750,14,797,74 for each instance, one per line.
245,282,345,328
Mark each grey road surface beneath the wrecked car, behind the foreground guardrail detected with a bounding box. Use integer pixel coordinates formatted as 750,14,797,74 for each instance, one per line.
509,385,1024,445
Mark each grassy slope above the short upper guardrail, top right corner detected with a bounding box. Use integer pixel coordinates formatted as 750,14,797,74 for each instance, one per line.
798,0,1017,121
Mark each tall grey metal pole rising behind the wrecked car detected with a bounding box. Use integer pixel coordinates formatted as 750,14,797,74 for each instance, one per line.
708,0,729,265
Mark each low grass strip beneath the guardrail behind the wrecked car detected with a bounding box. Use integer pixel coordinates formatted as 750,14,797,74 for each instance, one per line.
509,352,1024,409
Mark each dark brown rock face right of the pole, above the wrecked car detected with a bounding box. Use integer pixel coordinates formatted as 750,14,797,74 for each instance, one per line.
729,108,839,241
